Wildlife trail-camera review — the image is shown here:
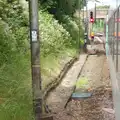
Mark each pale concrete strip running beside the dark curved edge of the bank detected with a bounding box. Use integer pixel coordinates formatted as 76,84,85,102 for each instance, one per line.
46,54,88,113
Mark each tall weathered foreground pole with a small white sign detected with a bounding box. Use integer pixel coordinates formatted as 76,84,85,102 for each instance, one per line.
29,0,42,120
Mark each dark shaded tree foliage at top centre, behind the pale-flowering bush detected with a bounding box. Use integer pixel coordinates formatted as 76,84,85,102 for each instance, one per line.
40,0,85,47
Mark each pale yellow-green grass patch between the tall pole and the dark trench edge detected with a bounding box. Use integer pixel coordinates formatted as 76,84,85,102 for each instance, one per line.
41,49,76,89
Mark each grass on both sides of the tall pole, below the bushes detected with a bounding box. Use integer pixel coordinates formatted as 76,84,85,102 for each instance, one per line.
0,49,75,120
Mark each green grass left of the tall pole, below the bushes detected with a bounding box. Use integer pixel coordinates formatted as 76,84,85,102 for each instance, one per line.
0,53,33,120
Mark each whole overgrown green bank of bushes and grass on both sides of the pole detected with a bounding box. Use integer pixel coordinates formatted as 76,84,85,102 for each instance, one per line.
0,0,83,120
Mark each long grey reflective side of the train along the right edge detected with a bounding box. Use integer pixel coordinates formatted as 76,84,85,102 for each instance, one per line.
105,6,120,120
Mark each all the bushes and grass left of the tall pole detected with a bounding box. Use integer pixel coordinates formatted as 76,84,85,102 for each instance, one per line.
0,1,33,120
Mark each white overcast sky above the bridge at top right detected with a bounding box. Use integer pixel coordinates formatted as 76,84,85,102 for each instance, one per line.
88,0,120,9
